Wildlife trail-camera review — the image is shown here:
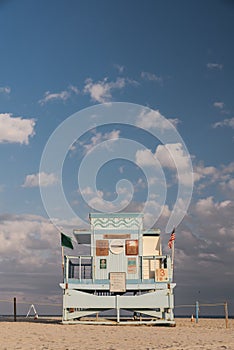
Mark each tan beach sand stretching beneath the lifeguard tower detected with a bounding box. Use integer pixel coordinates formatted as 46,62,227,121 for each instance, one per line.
0,318,234,350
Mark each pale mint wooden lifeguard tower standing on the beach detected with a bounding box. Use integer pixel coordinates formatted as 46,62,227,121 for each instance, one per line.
60,213,175,325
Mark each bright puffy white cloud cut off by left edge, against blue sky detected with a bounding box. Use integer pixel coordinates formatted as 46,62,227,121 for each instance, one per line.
0,113,35,145
